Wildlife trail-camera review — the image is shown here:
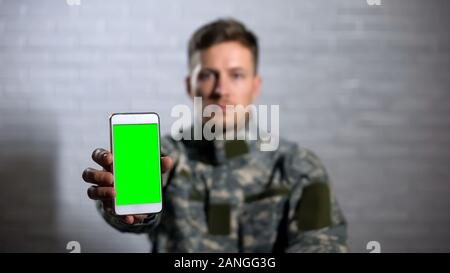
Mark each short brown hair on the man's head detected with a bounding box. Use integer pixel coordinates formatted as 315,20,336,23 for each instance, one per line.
188,18,259,73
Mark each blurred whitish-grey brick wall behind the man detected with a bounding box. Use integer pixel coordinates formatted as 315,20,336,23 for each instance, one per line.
0,0,450,252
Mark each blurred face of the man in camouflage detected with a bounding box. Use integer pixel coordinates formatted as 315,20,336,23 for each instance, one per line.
187,42,261,129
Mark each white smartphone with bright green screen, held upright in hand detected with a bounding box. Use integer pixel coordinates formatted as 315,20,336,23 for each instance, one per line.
109,113,162,215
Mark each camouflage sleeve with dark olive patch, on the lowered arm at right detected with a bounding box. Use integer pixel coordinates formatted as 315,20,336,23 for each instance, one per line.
286,148,348,253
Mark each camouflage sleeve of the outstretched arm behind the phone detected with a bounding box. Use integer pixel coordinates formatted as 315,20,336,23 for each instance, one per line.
96,136,180,233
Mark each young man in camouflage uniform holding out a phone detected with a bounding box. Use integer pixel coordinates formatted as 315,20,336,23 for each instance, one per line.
83,19,348,252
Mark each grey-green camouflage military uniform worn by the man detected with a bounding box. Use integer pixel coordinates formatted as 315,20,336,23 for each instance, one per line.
98,133,348,252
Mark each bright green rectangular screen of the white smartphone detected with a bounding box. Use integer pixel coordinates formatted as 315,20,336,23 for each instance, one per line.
113,124,161,206
